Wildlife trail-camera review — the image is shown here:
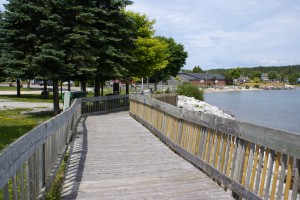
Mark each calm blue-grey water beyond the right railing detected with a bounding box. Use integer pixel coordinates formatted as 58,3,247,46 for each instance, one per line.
205,88,300,134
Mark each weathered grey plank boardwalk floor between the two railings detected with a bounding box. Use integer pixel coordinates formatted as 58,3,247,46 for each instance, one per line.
62,112,233,199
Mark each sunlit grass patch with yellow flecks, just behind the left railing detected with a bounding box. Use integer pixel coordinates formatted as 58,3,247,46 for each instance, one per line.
0,108,54,150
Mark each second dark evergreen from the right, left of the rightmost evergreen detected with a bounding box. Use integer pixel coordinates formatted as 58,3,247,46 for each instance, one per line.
63,0,99,91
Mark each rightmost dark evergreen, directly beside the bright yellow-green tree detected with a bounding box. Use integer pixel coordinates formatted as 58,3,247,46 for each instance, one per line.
93,0,134,96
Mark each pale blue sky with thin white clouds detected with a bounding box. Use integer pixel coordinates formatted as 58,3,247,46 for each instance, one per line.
0,0,300,70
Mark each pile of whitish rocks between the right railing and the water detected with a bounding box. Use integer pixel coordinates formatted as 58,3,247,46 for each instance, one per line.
178,96,234,119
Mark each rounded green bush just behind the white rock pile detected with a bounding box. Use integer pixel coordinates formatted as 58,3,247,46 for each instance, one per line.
176,83,204,101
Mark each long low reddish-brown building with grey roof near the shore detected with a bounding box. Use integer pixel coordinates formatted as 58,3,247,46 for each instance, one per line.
178,72,225,86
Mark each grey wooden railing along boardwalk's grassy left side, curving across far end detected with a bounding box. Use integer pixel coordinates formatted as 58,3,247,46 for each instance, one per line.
0,95,129,200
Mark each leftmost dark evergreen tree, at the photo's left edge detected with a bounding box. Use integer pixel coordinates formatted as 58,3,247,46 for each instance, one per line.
0,0,45,96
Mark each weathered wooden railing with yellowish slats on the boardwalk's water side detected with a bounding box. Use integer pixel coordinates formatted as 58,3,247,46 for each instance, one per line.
130,95,300,199
